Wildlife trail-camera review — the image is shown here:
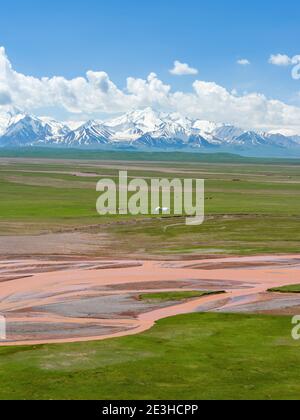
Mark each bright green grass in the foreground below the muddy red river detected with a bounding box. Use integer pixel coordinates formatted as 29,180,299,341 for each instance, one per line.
0,314,300,400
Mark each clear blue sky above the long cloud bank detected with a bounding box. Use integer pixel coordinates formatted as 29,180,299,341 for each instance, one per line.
0,0,300,131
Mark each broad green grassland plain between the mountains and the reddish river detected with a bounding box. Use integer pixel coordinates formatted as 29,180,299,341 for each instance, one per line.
0,152,300,255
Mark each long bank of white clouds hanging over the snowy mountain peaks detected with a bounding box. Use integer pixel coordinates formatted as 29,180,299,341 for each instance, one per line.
0,48,300,133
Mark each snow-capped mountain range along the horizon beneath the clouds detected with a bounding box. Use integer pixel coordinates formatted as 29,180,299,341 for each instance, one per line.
0,108,300,156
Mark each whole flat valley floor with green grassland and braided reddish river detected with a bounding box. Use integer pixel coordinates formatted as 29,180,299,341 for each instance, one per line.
0,155,300,400
